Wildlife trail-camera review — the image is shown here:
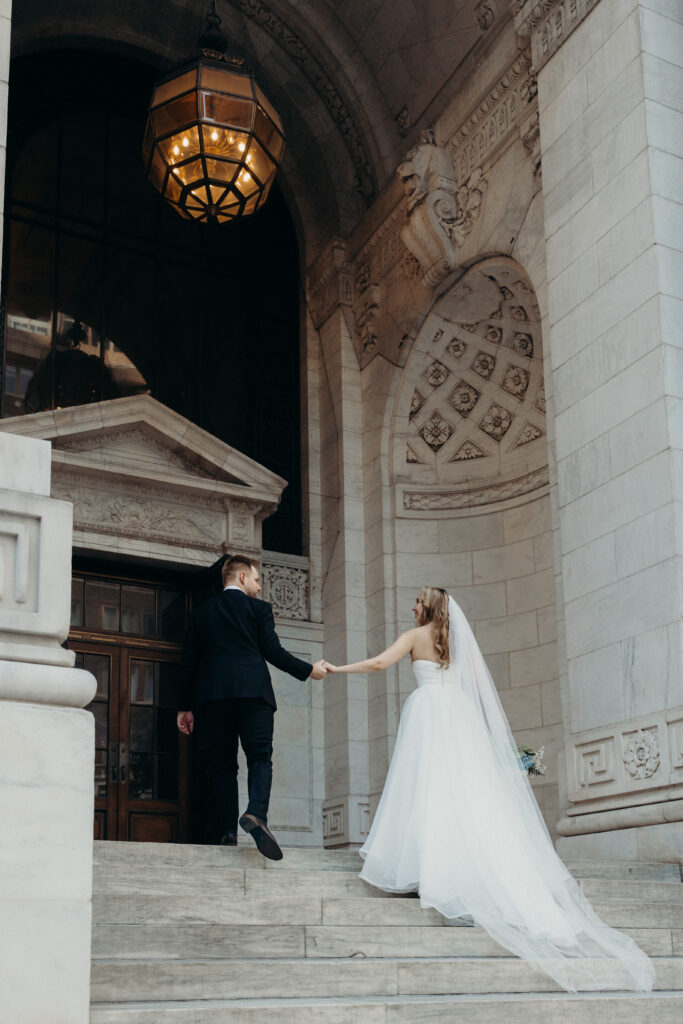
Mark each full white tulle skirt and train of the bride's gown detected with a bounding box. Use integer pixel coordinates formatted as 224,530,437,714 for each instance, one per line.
360,679,653,991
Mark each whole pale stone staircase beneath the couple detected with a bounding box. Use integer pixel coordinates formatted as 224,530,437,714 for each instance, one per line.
90,843,683,1024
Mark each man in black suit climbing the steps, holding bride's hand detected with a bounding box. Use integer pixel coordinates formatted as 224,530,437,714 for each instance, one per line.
178,555,327,860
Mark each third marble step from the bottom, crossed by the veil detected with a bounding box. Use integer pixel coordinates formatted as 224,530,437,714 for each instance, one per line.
92,923,683,959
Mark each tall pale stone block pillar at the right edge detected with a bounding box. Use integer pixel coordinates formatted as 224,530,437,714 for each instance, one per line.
513,0,683,860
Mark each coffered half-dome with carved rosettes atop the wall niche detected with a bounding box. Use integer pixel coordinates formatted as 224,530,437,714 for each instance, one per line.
390,256,548,512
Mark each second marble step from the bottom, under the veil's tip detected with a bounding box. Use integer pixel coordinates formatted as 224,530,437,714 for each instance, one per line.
90,957,683,1004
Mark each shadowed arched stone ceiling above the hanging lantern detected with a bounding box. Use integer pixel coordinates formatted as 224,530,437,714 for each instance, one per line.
12,0,497,240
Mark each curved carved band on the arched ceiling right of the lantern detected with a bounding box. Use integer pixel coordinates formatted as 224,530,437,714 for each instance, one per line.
230,0,376,205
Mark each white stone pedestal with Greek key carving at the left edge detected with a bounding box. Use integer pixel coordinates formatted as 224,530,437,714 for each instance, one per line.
0,434,95,1024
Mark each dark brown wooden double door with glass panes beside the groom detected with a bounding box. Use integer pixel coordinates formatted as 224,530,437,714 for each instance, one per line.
69,638,189,843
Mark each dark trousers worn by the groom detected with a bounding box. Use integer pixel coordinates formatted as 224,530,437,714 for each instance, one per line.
197,697,274,838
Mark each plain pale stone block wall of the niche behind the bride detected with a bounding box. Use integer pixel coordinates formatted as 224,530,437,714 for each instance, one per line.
395,496,562,833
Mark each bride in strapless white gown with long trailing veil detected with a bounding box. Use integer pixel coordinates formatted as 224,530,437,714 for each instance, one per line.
326,587,654,991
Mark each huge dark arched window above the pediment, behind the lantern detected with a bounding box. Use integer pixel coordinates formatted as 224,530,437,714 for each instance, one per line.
0,50,301,557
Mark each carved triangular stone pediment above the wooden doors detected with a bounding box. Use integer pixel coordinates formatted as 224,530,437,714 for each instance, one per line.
0,395,287,565
